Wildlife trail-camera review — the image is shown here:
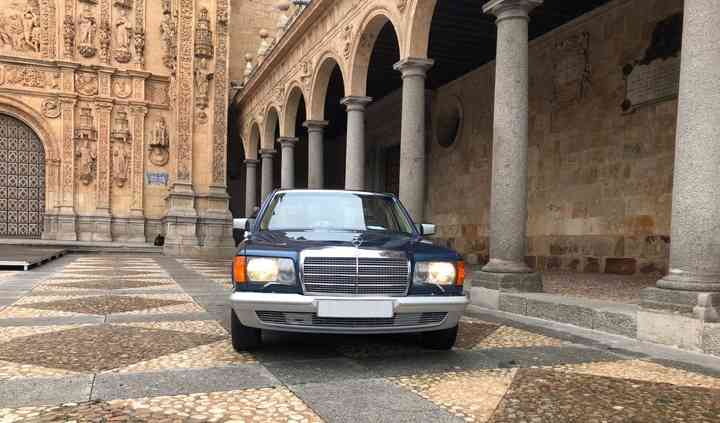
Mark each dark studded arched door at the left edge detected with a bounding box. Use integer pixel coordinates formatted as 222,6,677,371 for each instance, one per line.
0,114,45,238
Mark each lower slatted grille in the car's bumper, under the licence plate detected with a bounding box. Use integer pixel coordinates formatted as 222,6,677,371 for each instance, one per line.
255,311,447,328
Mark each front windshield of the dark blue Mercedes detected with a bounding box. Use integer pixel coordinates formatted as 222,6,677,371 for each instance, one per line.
260,192,414,234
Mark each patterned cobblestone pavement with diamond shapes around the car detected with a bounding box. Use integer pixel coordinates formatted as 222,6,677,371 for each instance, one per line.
0,255,720,423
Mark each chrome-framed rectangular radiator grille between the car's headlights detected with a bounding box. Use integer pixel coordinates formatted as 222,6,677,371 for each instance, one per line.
301,257,410,296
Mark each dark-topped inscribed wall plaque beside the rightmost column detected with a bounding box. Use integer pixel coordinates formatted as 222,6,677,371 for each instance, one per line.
622,14,682,112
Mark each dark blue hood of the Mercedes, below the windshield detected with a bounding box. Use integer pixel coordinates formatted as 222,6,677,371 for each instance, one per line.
240,231,457,258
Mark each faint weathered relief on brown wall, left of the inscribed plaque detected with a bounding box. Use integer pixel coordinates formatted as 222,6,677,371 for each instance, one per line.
553,32,592,109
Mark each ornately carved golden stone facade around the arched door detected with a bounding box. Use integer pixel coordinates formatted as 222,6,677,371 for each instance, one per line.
0,0,232,255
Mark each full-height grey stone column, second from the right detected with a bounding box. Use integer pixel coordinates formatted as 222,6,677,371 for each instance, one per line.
473,0,542,302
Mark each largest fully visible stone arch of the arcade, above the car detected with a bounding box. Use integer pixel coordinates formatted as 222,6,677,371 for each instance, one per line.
348,7,403,96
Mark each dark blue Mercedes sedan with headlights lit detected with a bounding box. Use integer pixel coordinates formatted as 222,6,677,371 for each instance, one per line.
230,190,467,351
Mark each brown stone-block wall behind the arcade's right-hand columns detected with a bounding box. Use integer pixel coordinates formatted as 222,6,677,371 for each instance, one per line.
430,0,682,274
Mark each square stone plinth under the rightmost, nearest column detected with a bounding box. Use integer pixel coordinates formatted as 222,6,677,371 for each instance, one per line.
640,287,720,322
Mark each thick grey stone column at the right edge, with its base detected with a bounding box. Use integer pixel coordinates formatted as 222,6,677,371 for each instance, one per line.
639,0,720,329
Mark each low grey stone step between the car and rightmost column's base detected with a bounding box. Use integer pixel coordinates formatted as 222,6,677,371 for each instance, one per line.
470,287,638,338
